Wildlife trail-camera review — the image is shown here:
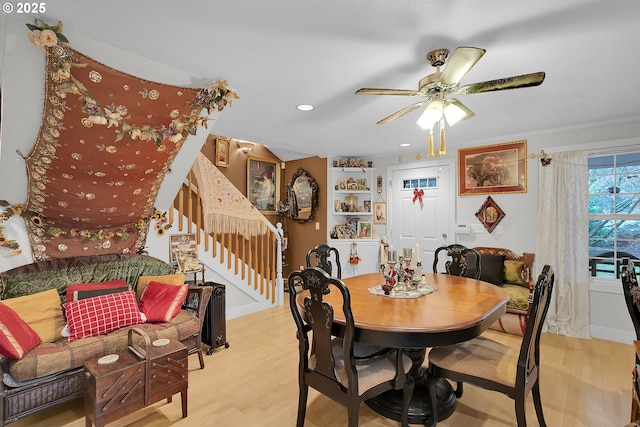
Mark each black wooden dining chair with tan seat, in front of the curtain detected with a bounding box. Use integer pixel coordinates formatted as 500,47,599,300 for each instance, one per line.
427,265,555,427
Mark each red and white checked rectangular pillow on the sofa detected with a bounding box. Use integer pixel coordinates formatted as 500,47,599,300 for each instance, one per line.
62,291,142,342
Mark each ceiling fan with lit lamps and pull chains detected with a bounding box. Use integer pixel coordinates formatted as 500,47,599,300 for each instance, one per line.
356,47,545,155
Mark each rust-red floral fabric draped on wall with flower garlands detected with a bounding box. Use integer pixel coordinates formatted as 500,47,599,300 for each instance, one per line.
18,23,237,260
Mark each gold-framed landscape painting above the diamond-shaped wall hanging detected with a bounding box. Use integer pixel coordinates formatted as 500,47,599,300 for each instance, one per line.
458,140,527,196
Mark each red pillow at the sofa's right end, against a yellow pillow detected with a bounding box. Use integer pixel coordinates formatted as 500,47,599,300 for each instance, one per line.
140,282,188,322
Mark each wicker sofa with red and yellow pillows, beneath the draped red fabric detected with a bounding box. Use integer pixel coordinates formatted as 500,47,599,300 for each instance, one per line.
0,255,212,427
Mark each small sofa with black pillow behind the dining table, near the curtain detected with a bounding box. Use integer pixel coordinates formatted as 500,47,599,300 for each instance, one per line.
467,246,535,336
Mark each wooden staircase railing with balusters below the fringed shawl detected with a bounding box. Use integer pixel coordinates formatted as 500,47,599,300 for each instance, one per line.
169,171,283,304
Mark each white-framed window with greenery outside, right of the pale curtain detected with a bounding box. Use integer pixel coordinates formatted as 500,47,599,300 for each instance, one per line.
589,152,640,279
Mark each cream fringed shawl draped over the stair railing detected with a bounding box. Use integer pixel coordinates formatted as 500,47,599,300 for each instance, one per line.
193,153,267,238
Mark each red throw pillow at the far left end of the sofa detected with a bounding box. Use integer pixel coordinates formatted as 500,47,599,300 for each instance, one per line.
0,303,40,359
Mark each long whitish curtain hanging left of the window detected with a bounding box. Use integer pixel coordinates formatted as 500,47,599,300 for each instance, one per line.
536,151,591,338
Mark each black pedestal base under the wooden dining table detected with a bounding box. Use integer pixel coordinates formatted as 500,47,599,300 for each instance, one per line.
365,350,456,426
